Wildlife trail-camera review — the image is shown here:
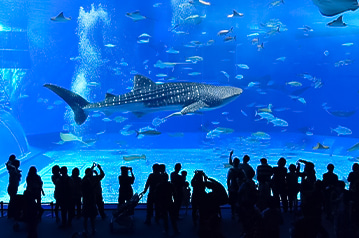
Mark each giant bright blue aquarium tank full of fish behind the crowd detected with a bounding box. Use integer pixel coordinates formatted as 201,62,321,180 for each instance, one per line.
0,0,359,203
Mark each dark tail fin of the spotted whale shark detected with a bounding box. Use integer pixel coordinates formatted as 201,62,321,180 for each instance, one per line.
44,84,89,125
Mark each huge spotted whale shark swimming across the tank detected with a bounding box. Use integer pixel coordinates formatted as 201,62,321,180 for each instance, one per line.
44,74,243,125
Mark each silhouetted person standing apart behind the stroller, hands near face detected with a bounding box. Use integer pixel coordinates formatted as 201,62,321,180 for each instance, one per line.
118,166,135,206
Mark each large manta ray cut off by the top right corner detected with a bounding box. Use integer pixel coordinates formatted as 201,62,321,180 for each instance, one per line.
313,0,359,17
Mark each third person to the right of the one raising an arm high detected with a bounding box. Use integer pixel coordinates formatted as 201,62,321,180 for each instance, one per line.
272,157,288,212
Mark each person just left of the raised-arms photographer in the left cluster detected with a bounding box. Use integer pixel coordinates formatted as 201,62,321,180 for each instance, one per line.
81,167,97,234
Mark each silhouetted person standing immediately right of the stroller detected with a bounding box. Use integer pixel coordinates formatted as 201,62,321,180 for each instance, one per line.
142,163,161,225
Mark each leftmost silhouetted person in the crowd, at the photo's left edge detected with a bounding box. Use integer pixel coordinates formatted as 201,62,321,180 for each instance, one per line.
5,155,21,218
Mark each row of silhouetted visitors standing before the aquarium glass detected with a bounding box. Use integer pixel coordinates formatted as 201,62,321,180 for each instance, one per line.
6,151,359,238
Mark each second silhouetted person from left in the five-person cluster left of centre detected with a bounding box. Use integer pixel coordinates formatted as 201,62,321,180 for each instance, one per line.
57,166,74,228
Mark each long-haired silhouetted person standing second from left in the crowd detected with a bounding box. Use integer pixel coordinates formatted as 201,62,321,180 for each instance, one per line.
26,166,45,217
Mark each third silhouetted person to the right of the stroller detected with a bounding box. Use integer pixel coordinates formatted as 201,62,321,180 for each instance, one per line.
171,163,185,219
